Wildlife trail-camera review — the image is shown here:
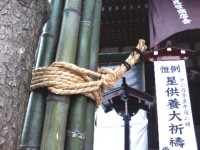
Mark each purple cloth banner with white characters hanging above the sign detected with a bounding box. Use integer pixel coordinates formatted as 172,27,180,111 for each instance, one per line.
149,0,200,48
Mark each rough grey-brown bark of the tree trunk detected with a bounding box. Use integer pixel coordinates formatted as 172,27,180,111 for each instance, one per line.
0,0,50,150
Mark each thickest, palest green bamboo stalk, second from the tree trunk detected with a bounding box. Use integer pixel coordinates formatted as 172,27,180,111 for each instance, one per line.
41,0,82,150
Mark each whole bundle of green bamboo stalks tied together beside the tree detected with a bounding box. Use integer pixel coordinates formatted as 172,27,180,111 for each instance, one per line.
21,0,144,150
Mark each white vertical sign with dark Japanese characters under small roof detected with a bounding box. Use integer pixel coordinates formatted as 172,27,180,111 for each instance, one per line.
154,60,197,150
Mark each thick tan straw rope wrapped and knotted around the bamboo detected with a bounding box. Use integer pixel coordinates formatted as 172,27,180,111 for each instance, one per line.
30,39,147,107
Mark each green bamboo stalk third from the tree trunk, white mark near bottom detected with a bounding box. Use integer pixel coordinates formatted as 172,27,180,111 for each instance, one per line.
66,0,95,150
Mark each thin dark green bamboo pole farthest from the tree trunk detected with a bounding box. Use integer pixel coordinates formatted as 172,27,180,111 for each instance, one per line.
84,0,102,150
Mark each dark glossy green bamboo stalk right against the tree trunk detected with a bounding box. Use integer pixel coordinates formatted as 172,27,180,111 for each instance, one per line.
20,0,63,150
